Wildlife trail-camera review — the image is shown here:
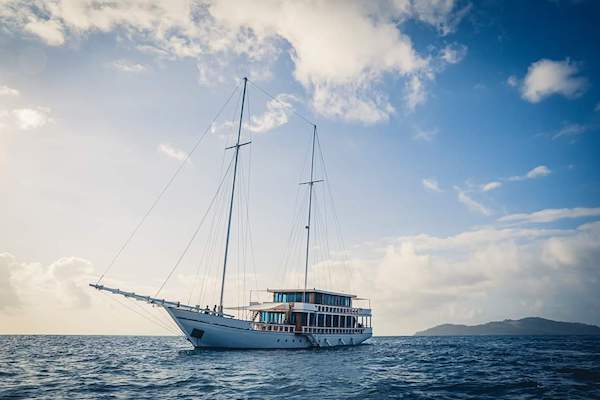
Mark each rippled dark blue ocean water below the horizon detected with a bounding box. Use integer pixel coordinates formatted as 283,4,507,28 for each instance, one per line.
0,336,600,399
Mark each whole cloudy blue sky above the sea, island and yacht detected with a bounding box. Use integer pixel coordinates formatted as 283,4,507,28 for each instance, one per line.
0,0,600,335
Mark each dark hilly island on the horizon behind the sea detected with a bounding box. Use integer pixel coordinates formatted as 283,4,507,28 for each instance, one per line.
415,317,600,336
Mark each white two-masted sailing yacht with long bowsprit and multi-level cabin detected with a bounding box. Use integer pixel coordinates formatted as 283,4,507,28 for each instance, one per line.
90,78,373,349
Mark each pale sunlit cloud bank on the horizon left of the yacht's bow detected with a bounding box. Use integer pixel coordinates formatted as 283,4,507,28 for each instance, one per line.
0,253,173,335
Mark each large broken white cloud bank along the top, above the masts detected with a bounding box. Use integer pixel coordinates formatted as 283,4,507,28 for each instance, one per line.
0,0,470,123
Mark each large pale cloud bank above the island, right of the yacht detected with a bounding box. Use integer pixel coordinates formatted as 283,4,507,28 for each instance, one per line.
311,222,600,335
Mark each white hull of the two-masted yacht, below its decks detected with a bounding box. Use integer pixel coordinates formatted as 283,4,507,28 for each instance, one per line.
165,306,372,349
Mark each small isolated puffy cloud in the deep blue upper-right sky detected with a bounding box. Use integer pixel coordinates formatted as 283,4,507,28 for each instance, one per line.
521,59,588,103
